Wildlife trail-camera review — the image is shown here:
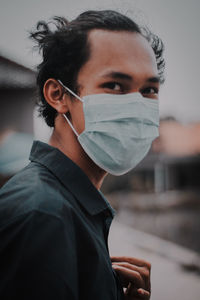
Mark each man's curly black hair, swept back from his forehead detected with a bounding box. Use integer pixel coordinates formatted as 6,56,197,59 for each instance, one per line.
30,10,165,127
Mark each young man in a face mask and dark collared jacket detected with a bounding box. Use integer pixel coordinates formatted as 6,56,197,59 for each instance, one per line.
0,11,164,300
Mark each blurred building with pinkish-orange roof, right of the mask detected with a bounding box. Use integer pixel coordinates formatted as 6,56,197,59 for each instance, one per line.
151,120,200,192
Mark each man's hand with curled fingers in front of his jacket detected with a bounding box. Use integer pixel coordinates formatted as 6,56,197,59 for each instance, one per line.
111,256,151,300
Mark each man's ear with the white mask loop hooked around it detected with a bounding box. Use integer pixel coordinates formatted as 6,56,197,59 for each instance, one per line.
43,78,69,114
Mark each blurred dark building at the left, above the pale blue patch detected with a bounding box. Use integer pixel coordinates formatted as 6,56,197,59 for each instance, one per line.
0,56,35,133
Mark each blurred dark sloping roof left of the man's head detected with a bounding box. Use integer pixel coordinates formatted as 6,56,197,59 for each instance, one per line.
0,55,36,89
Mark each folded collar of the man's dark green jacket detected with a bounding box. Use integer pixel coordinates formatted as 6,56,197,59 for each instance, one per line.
29,141,115,217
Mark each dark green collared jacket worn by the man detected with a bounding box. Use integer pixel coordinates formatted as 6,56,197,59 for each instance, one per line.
0,142,123,300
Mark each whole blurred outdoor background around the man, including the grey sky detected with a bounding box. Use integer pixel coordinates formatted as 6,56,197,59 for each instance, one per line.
0,0,200,300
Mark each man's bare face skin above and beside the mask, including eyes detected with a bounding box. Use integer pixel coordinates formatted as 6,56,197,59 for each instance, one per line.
71,29,159,133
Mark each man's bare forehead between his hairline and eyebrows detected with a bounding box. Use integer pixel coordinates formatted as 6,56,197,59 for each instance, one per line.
80,29,158,77
